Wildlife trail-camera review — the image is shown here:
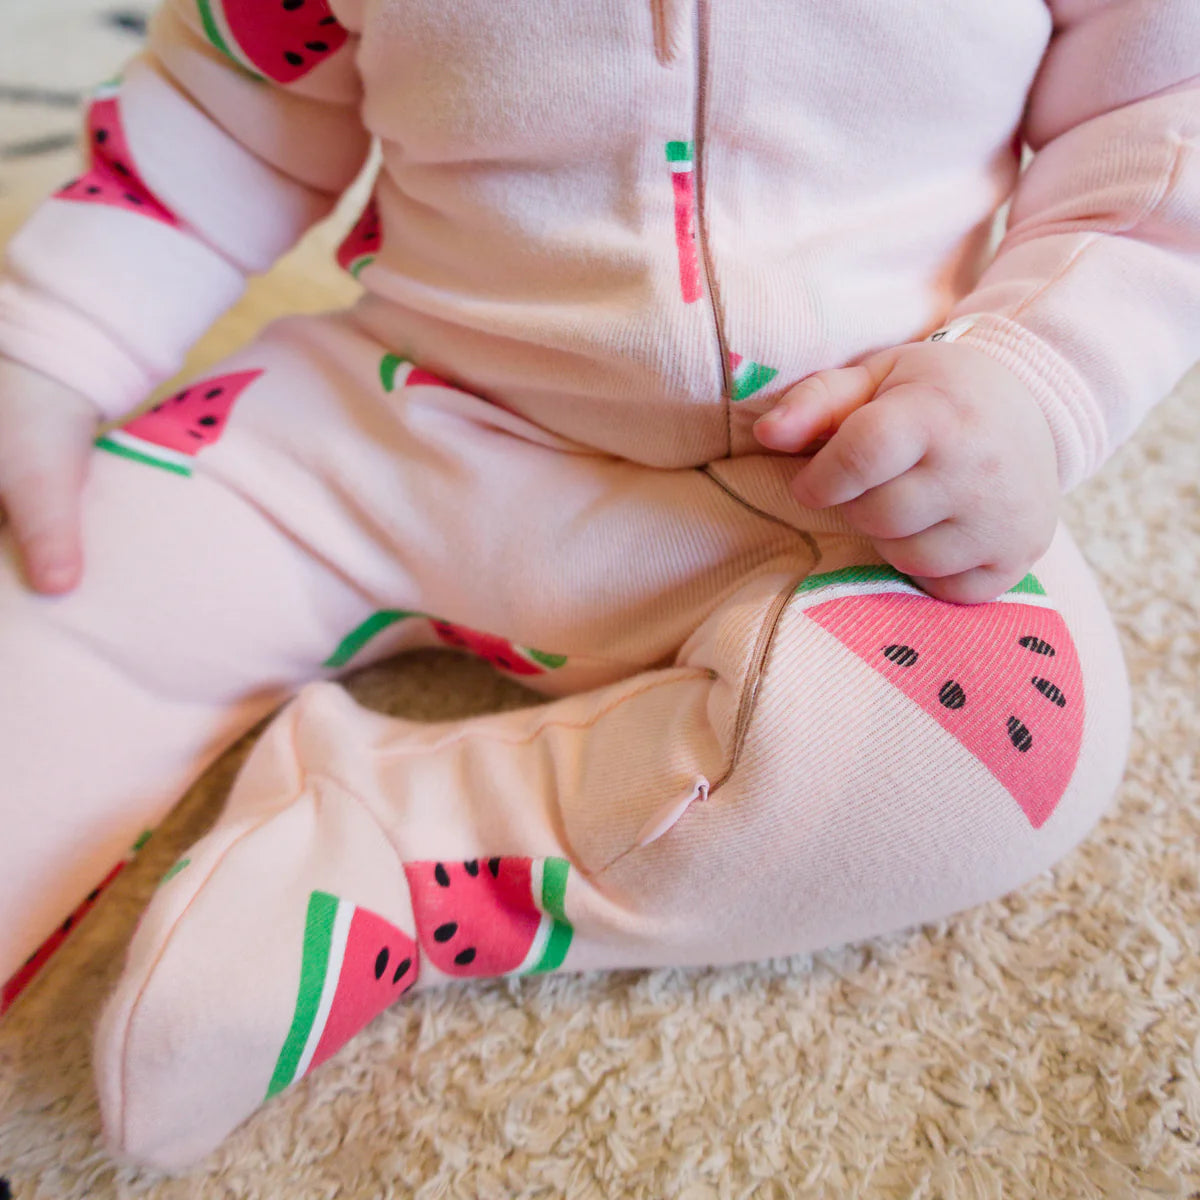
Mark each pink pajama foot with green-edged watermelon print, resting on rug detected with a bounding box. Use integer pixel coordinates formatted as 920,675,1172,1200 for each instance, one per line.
96,689,420,1170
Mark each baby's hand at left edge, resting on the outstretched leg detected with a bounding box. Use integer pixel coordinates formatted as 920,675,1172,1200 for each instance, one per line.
0,359,98,593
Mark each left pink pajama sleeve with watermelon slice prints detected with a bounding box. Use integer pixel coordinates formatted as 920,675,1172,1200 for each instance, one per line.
0,0,370,418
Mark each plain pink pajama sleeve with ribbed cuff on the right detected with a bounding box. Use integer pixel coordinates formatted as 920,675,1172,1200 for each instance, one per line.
935,0,1200,491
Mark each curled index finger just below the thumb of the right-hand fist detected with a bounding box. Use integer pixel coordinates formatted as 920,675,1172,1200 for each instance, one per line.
792,403,928,509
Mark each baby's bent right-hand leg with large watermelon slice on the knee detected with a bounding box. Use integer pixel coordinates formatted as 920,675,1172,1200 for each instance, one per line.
97,520,1128,1168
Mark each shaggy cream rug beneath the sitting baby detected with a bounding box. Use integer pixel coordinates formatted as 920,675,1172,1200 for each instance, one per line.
0,0,1200,1200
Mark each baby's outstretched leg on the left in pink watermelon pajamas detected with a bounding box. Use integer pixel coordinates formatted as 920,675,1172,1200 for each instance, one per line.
0,316,797,993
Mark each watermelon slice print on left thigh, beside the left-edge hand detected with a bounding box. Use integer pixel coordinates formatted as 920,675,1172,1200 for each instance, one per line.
96,371,263,476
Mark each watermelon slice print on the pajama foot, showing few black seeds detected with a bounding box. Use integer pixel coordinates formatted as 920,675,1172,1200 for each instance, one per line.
266,892,420,1098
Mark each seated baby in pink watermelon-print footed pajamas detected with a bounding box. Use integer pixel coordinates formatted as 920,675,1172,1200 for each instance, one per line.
0,0,1200,1168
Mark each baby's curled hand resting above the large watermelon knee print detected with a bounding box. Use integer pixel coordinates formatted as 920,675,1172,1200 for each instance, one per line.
755,342,1058,604
